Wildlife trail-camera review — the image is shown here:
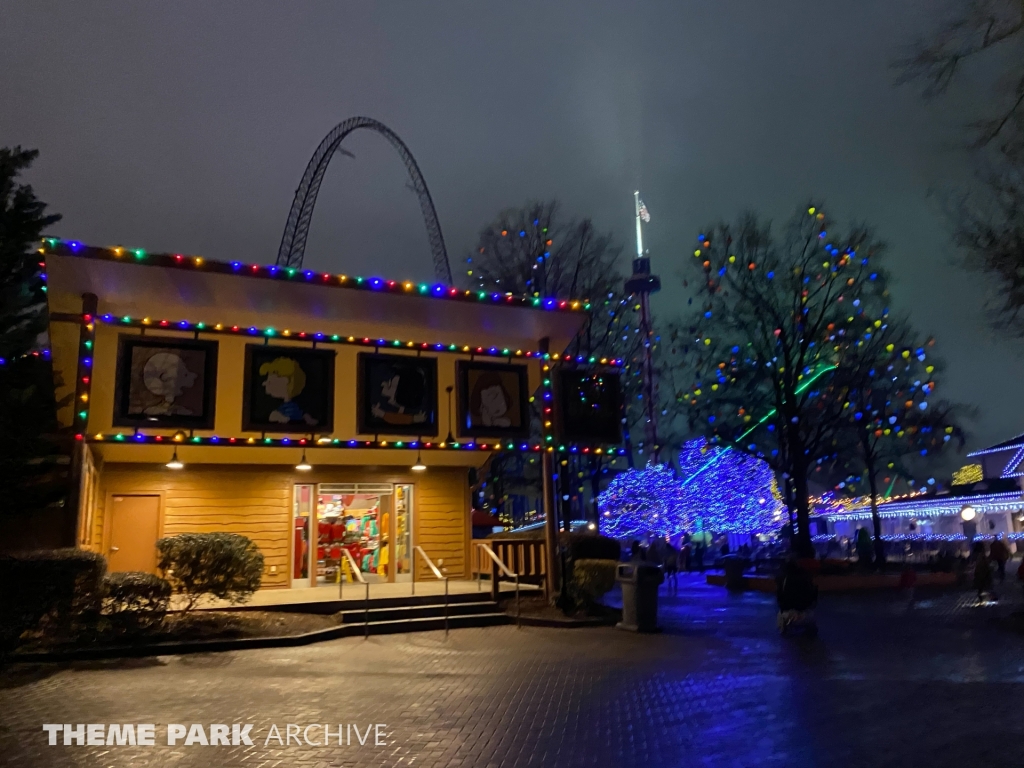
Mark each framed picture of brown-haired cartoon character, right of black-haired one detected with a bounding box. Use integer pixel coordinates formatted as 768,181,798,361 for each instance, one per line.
457,360,529,437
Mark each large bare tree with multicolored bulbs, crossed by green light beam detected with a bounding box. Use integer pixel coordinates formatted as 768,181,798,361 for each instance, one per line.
663,206,886,554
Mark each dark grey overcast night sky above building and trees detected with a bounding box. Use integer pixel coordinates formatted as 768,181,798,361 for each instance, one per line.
0,0,1024,456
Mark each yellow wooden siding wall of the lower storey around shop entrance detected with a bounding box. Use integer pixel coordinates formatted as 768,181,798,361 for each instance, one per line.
92,464,470,588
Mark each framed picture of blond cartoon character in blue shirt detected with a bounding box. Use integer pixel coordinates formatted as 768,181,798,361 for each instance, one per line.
242,344,335,434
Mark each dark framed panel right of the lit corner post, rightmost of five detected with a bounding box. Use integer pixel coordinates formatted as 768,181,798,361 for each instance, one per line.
556,370,623,443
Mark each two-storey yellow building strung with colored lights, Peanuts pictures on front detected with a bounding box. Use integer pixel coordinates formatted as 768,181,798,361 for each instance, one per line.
40,239,615,588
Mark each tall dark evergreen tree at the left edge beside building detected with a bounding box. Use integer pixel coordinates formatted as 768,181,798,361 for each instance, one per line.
0,146,63,513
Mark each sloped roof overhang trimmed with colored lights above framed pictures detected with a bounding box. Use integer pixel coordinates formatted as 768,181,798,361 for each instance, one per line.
40,241,598,366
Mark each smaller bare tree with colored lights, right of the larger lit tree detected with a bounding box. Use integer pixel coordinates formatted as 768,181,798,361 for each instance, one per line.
833,314,964,566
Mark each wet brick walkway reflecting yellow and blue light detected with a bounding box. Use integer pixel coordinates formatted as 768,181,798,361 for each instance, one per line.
0,578,1024,768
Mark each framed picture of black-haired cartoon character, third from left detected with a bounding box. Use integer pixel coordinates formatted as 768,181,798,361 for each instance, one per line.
356,352,437,435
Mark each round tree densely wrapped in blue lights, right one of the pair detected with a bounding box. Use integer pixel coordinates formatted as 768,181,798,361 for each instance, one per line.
679,438,786,534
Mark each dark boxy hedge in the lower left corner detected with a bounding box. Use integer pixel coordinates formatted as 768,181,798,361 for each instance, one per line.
0,549,106,652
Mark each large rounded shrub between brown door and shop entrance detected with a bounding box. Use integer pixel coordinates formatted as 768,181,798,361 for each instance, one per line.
157,534,263,610
